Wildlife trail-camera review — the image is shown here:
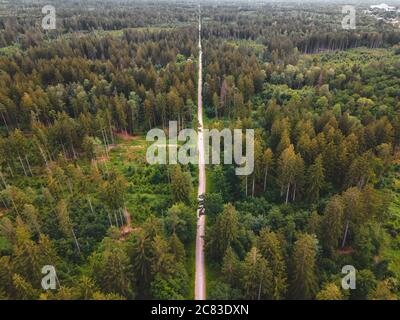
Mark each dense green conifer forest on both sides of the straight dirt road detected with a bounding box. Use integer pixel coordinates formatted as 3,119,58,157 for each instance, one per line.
0,0,400,300
